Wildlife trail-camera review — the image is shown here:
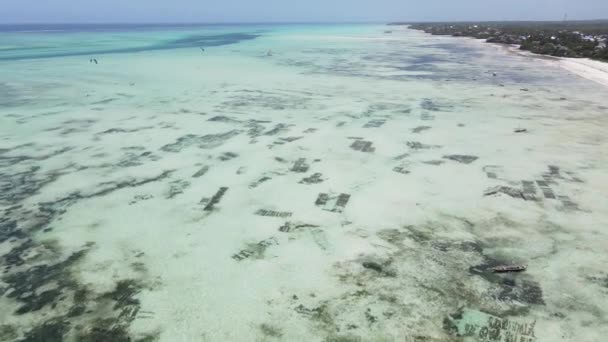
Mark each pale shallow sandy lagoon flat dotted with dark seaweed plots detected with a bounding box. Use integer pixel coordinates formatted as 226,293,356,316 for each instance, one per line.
0,26,608,342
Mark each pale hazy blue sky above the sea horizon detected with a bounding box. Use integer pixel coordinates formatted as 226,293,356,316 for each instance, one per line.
0,0,608,24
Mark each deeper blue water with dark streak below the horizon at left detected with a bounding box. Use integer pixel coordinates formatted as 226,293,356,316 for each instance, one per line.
0,24,261,61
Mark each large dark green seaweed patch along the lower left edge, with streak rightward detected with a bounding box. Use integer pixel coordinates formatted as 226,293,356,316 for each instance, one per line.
0,145,172,341
